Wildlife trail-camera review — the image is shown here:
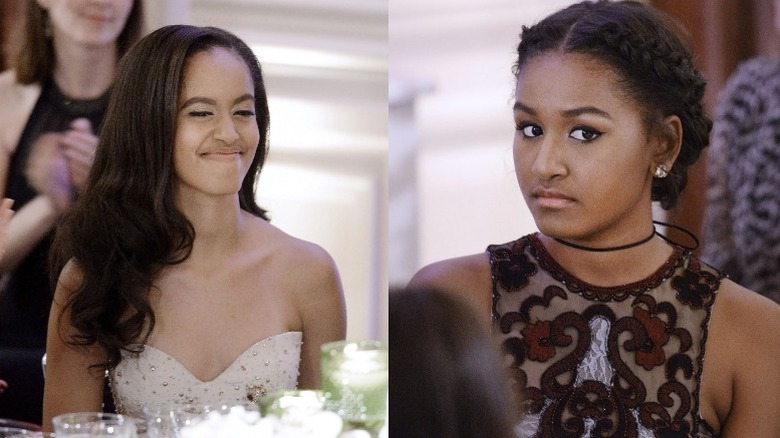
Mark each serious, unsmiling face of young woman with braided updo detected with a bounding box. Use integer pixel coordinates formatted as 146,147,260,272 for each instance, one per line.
513,52,658,246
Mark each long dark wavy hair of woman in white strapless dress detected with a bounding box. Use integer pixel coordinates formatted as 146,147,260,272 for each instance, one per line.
52,25,270,367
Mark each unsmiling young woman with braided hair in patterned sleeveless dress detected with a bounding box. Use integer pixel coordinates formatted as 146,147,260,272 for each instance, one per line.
410,1,780,437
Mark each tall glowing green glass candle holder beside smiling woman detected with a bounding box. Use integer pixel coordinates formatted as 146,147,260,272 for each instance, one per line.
320,340,387,435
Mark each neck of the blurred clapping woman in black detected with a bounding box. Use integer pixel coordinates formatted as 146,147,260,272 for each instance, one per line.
53,37,117,99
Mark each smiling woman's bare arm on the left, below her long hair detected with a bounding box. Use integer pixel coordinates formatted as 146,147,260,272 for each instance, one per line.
43,261,106,431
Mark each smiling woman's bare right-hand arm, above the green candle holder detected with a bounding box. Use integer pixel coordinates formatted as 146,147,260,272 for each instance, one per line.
296,248,347,389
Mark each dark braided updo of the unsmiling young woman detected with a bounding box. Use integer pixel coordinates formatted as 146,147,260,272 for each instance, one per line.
513,0,712,209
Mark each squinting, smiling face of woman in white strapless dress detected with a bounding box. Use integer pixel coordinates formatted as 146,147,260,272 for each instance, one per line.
173,47,260,201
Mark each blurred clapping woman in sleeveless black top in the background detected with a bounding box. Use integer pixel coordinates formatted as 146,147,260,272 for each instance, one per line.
0,0,143,424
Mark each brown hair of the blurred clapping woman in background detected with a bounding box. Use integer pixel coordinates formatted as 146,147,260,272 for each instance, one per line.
13,0,144,84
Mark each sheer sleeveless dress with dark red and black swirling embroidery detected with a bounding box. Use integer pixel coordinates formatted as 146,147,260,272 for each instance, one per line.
487,234,723,438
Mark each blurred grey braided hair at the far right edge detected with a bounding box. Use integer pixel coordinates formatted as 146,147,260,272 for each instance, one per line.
701,1,780,303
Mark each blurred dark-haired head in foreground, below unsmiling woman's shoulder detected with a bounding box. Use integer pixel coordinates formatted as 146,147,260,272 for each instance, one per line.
388,289,519,438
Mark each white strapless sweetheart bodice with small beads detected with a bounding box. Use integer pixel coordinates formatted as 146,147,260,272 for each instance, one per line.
109,332,303,418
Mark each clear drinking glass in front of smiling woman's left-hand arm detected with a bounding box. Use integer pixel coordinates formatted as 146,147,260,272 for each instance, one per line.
52,412,146,438
